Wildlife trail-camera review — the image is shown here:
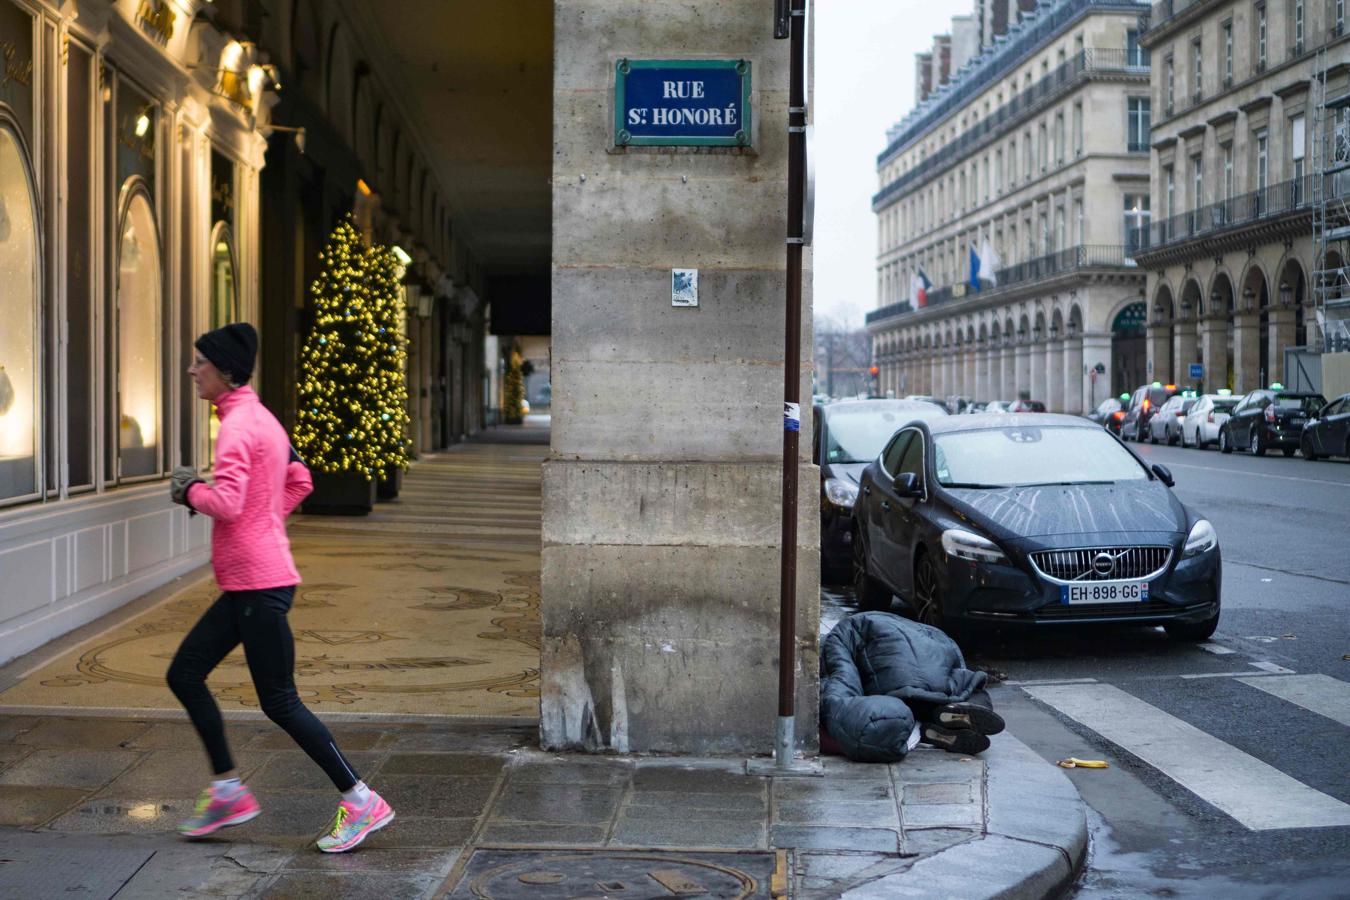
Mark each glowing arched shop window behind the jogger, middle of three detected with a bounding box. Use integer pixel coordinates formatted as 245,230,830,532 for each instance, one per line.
116,188,162,479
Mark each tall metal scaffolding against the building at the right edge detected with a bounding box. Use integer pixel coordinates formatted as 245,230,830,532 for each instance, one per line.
1312,47,1350,354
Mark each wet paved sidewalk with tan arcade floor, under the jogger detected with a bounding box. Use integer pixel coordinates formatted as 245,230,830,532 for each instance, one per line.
0,429,1087,900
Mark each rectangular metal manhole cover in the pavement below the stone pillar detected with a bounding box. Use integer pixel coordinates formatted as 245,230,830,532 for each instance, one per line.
450,850,774,900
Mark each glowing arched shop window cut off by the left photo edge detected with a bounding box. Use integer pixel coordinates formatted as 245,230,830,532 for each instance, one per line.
0,121,42,502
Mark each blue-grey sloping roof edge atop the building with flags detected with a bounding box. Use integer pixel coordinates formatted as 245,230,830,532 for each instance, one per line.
878,0,1148,162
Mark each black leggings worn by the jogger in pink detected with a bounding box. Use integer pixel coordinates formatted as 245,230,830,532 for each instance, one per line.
169,586,360,791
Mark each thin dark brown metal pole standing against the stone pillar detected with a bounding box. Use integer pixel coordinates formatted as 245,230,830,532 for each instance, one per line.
774,0,806,769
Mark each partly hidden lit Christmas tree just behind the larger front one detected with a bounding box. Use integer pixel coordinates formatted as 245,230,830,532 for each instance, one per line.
367,246,410,478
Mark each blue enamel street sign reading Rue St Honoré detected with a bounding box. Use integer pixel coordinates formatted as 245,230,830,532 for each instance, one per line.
614,59,751,147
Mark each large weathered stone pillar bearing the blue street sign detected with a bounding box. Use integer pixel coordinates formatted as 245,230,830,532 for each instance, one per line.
539,0,821,754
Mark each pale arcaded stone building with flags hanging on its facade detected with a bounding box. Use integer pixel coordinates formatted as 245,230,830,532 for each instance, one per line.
867,0,1152,413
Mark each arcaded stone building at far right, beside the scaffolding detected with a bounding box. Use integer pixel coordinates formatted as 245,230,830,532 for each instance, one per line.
1134,0,1350,393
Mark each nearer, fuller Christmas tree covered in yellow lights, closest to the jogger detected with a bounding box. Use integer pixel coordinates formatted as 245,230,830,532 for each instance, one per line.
294,216,385,480
